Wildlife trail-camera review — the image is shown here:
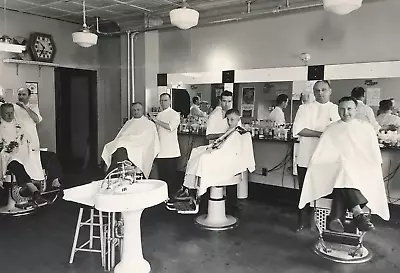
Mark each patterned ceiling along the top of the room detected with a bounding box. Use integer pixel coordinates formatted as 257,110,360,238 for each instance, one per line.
0,0,390,30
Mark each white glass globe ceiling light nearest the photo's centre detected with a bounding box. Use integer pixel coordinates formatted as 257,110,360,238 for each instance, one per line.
169,0,200,29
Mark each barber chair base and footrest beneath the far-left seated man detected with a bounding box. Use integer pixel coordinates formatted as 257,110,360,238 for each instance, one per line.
0,172,62,216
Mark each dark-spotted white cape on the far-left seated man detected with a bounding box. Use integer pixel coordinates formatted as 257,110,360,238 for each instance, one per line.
0,119,43,179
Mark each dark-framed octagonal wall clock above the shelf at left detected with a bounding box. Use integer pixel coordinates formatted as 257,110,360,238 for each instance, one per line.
28,32,57,63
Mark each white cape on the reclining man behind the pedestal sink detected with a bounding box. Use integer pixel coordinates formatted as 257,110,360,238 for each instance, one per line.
101,116,160,178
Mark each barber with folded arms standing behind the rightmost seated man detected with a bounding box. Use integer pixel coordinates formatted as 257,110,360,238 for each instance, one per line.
293,80,340,231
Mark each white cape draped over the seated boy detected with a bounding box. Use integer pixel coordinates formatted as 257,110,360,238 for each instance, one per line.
184,132,255,196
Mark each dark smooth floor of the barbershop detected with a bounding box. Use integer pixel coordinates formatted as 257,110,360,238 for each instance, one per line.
0,171,400,273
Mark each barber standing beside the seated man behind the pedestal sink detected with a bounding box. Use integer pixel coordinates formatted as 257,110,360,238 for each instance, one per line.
150,93,181,195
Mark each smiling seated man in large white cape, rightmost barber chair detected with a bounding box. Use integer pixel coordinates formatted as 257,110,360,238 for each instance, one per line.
299,97,390,232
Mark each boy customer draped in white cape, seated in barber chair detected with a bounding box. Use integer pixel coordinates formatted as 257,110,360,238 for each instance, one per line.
167,109,255,210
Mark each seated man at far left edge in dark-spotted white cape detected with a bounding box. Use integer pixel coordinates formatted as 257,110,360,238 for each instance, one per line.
0,103,47,206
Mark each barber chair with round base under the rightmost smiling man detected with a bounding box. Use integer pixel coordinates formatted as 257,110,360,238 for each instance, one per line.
311,198,372,264
